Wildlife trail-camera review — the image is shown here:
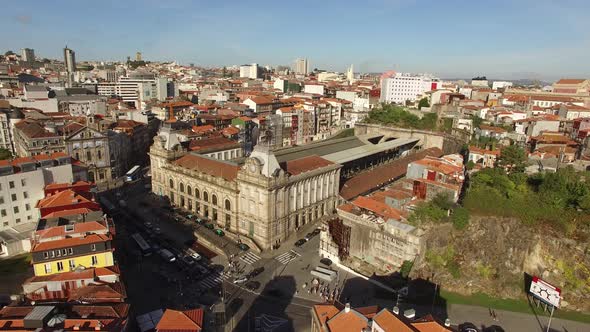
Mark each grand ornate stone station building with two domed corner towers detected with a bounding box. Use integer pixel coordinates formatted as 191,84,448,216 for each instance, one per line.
150,136,341,250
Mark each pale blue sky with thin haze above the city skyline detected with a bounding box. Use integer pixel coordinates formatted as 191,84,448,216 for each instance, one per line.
0,0,590,80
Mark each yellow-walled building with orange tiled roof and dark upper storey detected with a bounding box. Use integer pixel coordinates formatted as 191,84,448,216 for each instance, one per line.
31,234,114,276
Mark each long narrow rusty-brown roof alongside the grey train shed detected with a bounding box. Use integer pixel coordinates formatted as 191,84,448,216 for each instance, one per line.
340,148,443,200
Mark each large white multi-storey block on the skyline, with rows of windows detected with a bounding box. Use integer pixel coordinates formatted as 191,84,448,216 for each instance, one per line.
381,72,442,104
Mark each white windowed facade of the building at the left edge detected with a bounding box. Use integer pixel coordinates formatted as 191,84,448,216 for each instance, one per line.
0,164,74,231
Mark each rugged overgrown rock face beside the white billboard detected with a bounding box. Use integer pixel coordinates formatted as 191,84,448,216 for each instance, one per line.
412,217,590,312
